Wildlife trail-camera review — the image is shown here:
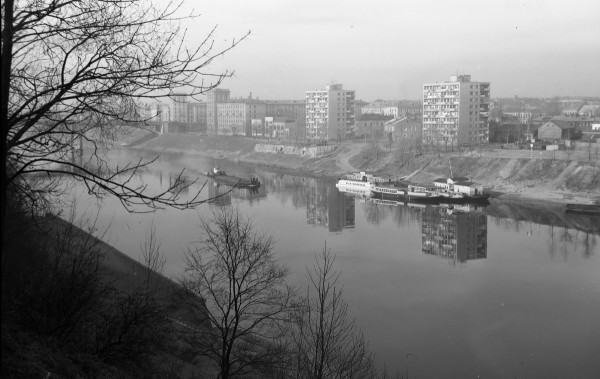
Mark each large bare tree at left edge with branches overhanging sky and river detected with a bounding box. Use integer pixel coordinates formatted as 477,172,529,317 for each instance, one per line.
0,0,248,255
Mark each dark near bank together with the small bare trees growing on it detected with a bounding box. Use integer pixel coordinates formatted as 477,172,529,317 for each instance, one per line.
1,197,408,378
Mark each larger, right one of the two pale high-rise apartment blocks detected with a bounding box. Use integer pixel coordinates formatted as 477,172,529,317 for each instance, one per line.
423,75,490,146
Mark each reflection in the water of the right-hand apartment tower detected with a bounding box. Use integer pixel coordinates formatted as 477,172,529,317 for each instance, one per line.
421,206,487,262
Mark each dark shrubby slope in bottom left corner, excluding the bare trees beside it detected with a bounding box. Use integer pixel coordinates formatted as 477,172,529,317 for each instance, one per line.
1,200,209,378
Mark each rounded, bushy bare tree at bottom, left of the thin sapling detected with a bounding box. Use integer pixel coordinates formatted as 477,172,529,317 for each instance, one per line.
183,208,293,378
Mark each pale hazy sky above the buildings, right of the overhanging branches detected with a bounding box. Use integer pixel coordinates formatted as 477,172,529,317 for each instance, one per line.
186,0,600,100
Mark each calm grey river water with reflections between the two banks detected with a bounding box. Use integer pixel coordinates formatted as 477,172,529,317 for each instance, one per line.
67,149,600,378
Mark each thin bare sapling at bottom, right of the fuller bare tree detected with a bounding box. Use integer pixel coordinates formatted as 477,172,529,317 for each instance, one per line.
293,245,376,379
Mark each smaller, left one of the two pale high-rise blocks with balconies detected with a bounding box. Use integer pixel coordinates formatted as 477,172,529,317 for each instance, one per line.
306,84,355,142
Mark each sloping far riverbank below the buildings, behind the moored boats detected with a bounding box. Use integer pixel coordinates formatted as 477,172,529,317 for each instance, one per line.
134,135,600,205
